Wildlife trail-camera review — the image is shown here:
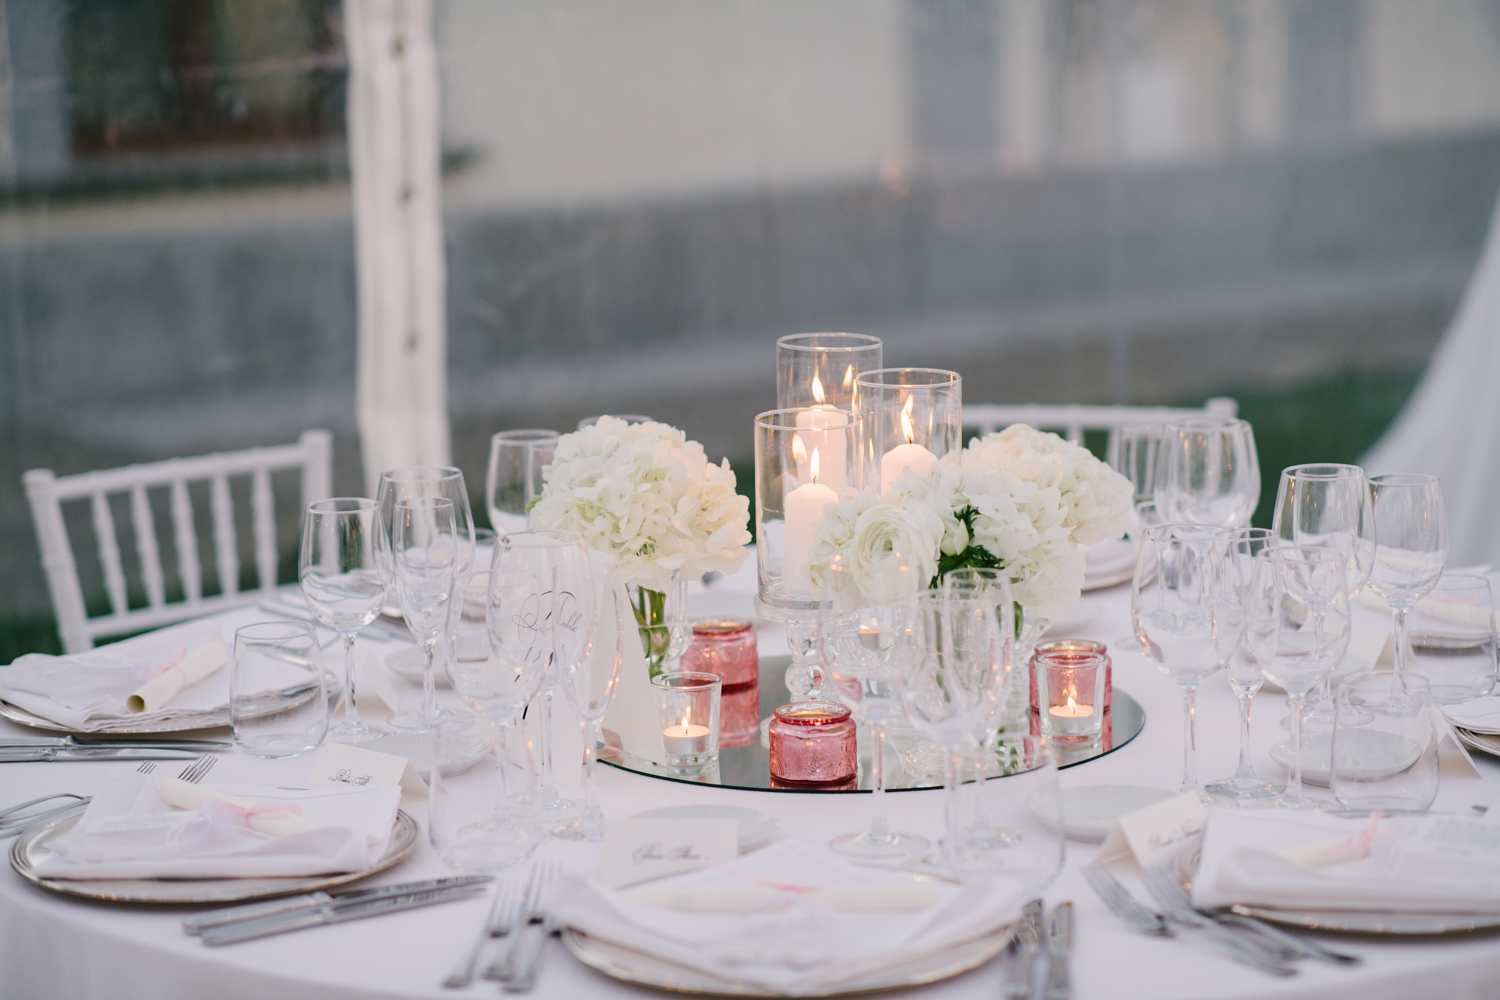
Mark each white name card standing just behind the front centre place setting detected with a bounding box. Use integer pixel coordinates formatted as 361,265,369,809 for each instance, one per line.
599,819,740,889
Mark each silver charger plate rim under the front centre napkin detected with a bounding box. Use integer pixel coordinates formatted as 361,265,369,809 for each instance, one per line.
563,927,1013,997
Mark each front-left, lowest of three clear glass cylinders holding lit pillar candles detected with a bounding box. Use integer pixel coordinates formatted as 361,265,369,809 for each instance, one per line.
755,406,864,611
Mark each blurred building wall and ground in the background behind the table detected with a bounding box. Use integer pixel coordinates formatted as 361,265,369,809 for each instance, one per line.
0,0,1500,663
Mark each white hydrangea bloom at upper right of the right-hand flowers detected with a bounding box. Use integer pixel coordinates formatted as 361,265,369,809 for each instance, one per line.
959,424,1133,546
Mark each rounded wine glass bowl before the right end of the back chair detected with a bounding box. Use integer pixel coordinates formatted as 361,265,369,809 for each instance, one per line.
1152,417,1260,528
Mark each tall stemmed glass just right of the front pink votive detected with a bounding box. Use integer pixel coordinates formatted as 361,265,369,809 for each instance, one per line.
818,550,927,858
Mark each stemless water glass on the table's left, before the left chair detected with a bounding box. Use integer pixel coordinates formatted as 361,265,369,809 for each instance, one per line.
230,622,329,757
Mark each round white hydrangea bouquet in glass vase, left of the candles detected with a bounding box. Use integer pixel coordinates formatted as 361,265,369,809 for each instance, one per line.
530,417,750,676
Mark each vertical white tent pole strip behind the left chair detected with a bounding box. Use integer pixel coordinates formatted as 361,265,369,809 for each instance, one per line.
344,0,450,496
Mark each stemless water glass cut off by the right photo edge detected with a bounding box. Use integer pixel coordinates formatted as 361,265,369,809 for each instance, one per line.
1407,573,1496,705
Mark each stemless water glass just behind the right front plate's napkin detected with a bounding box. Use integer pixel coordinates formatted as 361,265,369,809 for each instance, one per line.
1329,670,1443,813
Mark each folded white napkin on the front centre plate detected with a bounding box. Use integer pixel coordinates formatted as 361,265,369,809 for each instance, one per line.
554,840,1022,996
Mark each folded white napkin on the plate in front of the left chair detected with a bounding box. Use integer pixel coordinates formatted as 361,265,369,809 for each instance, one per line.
0,619,230,733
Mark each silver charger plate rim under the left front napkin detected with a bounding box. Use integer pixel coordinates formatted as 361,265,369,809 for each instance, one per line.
11,804,419,906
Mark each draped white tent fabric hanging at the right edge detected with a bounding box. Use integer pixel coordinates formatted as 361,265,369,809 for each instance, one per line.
1362,187,1500,565
